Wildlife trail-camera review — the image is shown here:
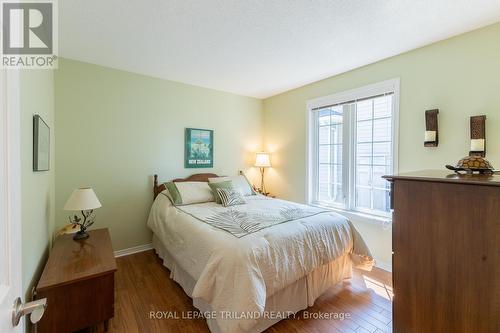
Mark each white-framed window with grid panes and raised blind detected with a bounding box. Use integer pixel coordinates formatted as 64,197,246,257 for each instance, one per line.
308,79,399,216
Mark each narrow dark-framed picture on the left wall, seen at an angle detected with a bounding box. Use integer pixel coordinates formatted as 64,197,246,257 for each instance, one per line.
33,115,50,171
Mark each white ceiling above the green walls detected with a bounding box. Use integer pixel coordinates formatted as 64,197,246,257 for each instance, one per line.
59,0,500,98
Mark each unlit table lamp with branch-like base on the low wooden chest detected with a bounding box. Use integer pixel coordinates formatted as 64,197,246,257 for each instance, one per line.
64,187,101,240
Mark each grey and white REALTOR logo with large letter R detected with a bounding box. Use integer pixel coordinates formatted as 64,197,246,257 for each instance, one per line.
1,0,57,69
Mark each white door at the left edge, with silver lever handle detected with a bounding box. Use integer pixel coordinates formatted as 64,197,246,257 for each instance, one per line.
0,70,24,333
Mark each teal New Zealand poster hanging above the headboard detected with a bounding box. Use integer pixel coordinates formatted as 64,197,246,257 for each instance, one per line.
184,128,214,168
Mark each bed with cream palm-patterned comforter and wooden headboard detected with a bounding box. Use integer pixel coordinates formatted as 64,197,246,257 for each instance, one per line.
148,174,374,333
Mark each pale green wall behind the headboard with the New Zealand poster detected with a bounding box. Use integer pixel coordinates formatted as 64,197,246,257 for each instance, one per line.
55,59,262,250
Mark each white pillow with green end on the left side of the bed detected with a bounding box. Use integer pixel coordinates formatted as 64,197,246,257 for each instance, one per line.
165,182,214,206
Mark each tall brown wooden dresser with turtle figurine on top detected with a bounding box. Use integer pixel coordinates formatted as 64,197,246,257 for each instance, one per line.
384,170,500,333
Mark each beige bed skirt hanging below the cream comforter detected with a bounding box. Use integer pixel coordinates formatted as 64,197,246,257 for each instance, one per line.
153,235,352,333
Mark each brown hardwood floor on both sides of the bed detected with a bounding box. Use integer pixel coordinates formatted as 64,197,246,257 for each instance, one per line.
80,251,392,333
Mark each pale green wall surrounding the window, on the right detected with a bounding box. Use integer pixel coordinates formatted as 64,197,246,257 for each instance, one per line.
264,24,500,263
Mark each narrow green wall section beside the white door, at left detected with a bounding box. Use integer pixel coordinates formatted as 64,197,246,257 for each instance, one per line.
20,70,55,300
